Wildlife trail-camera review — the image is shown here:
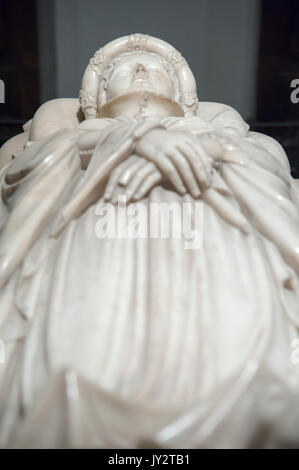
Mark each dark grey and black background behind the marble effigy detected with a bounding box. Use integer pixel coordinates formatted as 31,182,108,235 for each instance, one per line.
0,0,299,174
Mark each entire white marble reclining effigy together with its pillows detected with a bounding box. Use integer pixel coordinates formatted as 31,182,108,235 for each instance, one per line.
0,34,299,448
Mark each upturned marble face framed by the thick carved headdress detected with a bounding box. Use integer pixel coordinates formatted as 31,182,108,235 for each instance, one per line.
108,53,175,100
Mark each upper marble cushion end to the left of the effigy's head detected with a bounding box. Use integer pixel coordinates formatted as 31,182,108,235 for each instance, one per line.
29,98,84,141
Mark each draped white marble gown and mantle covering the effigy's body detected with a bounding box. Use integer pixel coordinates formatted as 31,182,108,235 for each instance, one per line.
0,106,299,447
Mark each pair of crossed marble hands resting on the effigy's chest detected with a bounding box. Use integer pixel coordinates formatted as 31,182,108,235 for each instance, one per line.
104,129,239,203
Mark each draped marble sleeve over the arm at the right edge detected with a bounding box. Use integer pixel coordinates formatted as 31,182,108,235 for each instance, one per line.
221,135,299,274
